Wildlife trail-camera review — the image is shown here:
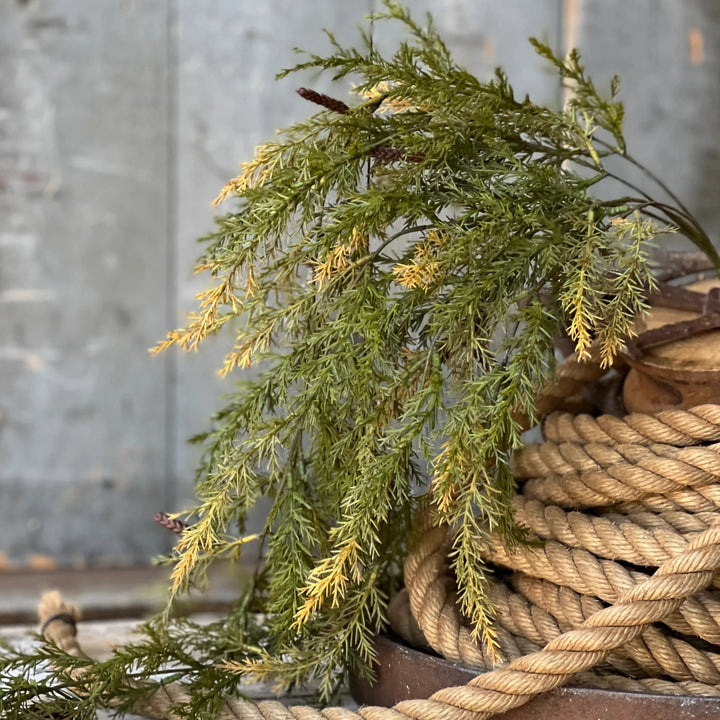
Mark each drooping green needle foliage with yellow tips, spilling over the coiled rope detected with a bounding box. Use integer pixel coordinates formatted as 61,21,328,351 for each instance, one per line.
0,1,718,717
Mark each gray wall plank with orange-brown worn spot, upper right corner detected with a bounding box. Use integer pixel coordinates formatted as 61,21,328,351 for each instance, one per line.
568,0,720,247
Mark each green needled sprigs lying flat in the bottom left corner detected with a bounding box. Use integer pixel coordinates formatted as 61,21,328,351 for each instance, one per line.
0,604,263,720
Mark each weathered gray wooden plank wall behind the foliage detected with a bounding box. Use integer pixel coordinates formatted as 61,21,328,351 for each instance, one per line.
0,0,720,567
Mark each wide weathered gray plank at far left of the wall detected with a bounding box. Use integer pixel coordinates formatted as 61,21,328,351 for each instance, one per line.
0,0,167,566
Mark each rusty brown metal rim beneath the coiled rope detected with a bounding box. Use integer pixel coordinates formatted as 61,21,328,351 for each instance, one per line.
351,636,720,720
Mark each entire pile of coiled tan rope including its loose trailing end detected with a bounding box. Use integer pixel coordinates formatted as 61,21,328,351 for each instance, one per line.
39,348,720,720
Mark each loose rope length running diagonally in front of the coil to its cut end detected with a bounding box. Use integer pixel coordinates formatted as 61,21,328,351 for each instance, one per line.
40,524,720,720
